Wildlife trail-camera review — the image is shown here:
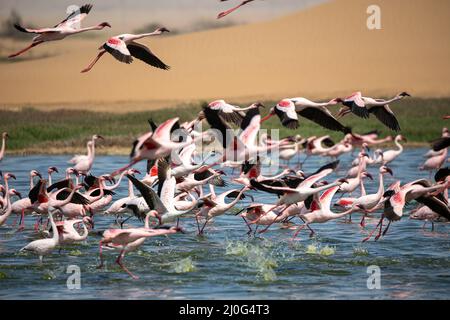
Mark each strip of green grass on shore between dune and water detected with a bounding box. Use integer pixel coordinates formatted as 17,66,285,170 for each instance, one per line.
0,98,450,154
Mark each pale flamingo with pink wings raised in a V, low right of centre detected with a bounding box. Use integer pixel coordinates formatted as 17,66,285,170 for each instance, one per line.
292,185,360,240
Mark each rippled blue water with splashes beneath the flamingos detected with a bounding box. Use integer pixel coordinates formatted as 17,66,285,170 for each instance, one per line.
0,149,450,299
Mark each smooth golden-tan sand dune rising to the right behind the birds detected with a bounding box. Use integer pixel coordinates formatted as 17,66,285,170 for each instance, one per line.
0,0,450,112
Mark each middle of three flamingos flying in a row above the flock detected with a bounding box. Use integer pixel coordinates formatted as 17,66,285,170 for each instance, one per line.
261,98,351,134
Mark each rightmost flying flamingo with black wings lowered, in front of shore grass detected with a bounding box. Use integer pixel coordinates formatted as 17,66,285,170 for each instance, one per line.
336,92,410,131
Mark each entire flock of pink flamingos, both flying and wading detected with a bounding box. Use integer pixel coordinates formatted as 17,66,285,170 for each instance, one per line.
0,0,450,278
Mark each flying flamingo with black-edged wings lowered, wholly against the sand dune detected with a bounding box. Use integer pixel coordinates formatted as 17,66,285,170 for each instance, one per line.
81,28,170,73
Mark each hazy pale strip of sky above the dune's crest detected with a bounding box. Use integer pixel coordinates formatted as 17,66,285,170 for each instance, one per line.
0,0,327,30
